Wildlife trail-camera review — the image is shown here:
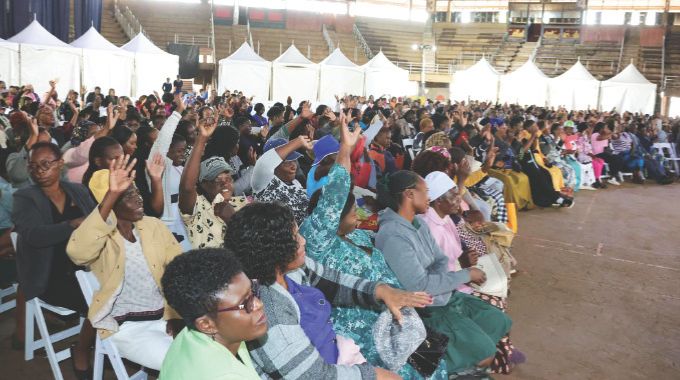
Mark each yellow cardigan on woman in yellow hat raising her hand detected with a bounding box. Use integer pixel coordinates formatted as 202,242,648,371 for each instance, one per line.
66,207,182,339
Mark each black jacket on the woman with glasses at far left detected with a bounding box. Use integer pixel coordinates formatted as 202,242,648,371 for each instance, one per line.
12,182,97,300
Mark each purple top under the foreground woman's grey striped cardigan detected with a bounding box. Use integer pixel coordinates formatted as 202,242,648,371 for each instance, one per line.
284,276,338,364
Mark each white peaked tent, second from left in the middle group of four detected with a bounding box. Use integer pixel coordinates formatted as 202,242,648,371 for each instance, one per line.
272,45,319,107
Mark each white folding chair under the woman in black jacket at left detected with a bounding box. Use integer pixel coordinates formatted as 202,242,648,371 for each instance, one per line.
10,232,84,380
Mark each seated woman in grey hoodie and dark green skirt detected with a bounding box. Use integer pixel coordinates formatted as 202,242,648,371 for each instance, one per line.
375,171,512,378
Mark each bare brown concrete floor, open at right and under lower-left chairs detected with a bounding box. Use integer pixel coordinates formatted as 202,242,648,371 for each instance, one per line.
0,184,680,380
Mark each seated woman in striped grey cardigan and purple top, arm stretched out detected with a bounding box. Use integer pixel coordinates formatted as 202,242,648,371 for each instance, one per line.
225,203,430,379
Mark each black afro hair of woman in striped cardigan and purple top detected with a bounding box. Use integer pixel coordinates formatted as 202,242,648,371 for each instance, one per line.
224,203,298,286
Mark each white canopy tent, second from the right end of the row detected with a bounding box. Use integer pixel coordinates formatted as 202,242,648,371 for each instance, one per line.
548,60,600,111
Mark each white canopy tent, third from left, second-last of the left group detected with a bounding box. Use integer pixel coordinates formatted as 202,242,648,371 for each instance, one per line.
71,27,134,96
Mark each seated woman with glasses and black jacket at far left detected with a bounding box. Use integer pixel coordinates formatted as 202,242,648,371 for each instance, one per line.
13,142,96,379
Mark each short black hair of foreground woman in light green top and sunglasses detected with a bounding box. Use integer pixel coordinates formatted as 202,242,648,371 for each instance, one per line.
161,248,243,329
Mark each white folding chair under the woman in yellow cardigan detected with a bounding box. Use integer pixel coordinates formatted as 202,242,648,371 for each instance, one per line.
76,270,148,380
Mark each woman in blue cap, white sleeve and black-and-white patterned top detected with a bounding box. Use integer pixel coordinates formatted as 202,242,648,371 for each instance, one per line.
252,136,312,224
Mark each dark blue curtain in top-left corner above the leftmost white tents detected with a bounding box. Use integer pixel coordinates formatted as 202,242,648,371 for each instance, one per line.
0,0,69,42
